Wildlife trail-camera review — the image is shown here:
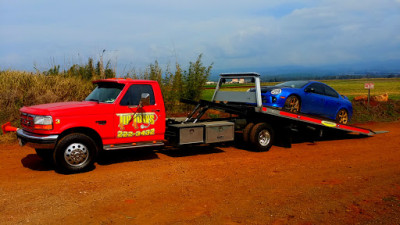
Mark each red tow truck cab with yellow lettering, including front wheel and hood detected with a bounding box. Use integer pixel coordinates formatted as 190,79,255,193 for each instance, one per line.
17,79,166,172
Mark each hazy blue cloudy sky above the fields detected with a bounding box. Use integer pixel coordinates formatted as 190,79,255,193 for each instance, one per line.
0,0,400,74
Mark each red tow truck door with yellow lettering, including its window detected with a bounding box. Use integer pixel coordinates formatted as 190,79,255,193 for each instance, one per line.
114,84,165,143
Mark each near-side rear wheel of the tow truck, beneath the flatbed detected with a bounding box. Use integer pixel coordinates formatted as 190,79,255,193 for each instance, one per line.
250,123,274,152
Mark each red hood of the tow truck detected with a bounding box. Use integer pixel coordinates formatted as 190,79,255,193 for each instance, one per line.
20,101,114,116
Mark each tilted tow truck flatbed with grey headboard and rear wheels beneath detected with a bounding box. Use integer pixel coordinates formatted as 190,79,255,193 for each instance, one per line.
176,73,386,151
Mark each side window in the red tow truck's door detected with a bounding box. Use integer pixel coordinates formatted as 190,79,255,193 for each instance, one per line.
120,84,155,105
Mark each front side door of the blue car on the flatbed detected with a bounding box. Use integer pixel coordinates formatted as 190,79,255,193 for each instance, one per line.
301,83,325,116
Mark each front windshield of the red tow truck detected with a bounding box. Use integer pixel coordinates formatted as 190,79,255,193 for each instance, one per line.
85,82,125,103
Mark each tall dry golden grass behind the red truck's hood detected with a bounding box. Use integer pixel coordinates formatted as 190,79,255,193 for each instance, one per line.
0,70,93,130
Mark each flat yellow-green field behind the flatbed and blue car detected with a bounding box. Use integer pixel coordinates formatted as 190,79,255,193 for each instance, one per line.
202,78,400,100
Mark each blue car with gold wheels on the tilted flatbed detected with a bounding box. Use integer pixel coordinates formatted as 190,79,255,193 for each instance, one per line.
249,81,353,124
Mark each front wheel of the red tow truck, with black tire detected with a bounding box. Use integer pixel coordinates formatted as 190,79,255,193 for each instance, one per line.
53,133,97,173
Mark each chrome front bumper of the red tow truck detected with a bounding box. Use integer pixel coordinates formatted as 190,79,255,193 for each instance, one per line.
17,129,58,149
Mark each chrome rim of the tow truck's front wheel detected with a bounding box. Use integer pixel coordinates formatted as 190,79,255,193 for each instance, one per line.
64,143,89,166
